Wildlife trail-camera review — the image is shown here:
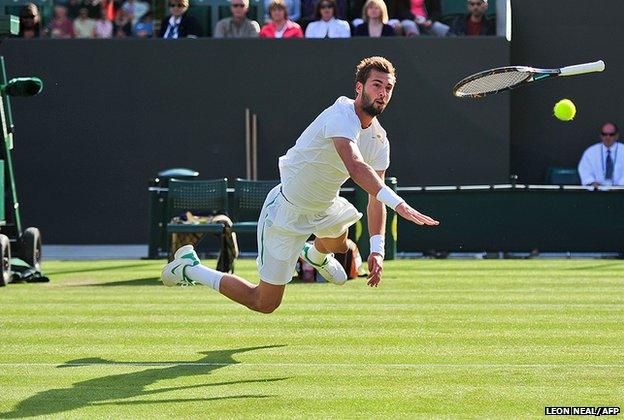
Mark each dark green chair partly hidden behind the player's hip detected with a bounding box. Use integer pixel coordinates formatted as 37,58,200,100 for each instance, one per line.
233,178,280,233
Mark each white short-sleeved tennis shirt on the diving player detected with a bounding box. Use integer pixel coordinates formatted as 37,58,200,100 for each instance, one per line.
279,96,390,212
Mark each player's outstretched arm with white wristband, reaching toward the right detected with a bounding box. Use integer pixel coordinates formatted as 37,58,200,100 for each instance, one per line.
333,137,440,226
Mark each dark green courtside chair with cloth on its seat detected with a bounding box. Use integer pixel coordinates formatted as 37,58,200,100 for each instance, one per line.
166,178,228,254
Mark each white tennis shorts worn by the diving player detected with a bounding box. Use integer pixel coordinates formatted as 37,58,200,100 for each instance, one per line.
256,185,362,285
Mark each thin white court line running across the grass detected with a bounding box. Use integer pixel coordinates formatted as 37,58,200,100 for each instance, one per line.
0,362,624,369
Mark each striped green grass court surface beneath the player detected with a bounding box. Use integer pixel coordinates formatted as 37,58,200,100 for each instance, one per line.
0,260,624,418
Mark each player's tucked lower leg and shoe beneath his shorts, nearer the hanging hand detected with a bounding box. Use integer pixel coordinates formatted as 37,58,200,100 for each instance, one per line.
301,231,349,285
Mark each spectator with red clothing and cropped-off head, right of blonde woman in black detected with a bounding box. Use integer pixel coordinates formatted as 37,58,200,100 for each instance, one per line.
388,0,450,36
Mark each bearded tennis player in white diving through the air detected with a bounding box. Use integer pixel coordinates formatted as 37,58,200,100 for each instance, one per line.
162,57,438,313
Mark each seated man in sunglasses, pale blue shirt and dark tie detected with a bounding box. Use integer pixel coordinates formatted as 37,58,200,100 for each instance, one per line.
578,122,624,187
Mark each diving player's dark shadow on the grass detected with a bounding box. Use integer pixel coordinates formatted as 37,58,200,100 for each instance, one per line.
0,345,288,418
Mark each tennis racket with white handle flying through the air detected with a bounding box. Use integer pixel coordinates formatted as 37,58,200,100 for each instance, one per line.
453,60,605,98
